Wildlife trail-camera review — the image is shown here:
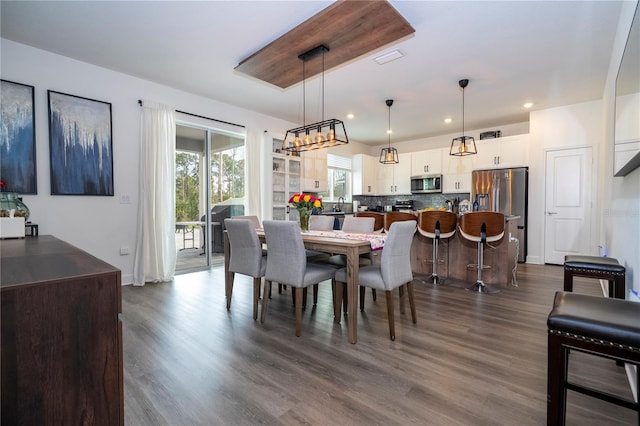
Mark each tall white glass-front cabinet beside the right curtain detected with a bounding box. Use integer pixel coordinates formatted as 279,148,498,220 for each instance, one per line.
271,139,302,220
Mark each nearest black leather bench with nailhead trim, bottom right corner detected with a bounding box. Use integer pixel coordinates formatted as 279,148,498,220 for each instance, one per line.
547,292,640,425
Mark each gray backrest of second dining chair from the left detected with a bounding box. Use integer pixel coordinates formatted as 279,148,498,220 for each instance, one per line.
263,220,307,287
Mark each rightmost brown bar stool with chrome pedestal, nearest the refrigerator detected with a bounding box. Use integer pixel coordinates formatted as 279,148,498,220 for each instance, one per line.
459,212,504,293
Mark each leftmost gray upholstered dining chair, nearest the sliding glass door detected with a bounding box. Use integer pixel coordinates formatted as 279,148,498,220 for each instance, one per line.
224,218,267,320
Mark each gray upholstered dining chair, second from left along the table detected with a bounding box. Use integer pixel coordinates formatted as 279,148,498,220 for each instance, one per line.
260,220,336,336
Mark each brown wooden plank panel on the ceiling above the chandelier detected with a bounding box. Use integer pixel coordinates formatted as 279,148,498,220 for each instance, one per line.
235,1,415,89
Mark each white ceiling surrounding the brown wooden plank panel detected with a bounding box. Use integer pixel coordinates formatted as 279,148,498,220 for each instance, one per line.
0,0,621,145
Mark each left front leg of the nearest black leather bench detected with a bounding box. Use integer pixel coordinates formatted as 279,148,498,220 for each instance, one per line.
547,333,569,426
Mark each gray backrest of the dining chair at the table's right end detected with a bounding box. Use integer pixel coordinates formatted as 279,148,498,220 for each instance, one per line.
380,220,417,290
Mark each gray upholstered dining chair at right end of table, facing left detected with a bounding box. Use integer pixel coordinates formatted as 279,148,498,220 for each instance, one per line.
335,221,416,340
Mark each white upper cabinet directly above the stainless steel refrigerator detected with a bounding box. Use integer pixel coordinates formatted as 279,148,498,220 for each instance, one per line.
473,135,529,170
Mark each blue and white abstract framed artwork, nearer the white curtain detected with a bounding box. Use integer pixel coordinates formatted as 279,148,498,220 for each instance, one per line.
47,90,113,196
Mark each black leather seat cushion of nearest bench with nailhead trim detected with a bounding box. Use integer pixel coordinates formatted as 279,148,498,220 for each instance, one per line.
547,291,640,348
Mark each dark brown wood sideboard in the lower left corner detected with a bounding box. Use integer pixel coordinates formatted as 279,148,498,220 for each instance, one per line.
0,235,124,425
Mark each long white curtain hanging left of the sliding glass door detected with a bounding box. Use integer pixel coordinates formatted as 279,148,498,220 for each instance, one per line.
133,102,176,285
